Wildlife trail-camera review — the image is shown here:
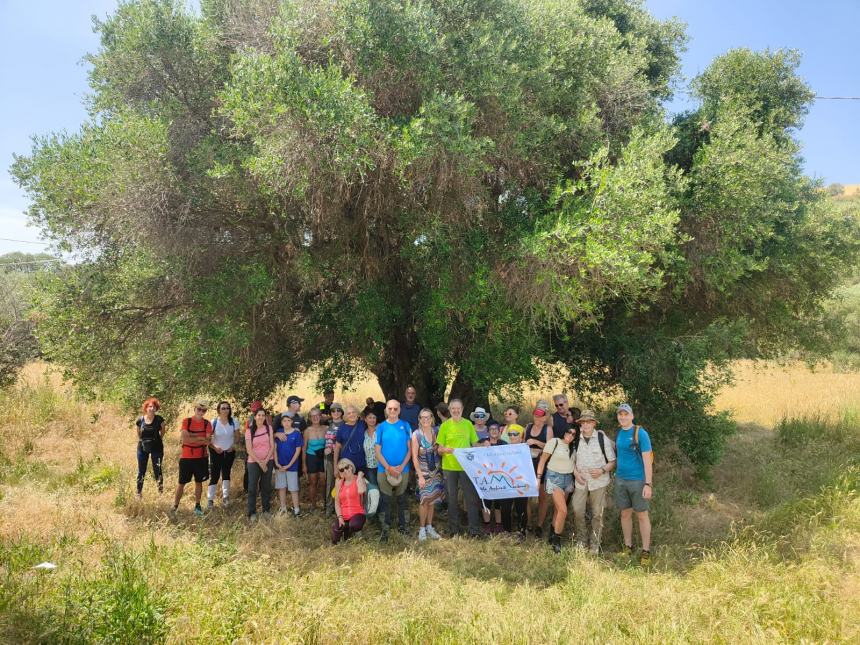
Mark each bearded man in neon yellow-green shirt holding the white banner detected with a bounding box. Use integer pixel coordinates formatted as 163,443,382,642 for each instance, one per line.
436,399,484,538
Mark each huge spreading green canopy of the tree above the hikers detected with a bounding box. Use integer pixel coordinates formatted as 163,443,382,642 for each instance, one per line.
12,0,858,464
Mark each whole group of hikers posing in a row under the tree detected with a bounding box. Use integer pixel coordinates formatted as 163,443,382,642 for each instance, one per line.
136,386,653,564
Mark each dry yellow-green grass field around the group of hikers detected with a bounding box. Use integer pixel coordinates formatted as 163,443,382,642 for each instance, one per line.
0,364,860,644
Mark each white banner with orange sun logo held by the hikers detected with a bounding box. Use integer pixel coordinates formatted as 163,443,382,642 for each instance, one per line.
454,443,538,499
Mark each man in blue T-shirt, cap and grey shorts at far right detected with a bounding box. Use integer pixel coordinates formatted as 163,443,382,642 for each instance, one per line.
615,403,654,564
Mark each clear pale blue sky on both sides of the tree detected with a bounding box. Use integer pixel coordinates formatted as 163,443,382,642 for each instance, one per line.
0,0,860,254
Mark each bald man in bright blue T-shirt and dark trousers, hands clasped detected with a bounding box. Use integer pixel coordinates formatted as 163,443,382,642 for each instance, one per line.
376,399,412,542
